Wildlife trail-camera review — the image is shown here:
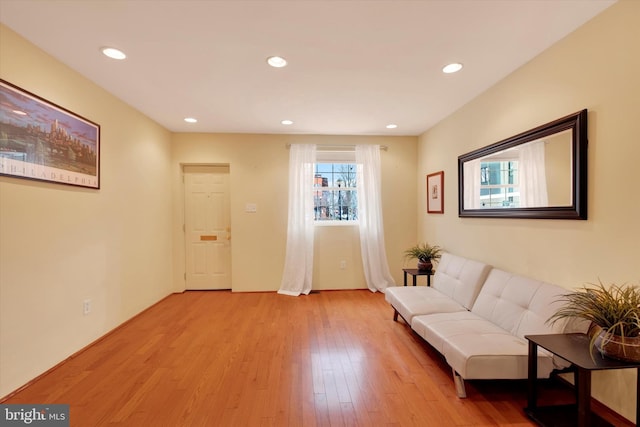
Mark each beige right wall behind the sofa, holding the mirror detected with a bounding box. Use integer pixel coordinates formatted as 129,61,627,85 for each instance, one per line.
417,1,640,419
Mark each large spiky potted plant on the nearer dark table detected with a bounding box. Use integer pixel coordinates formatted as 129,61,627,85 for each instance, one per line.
549,283,640,362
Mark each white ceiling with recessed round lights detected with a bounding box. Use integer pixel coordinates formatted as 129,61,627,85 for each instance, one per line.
0,0,614,135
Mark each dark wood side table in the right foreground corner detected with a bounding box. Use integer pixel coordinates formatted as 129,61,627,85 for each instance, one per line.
525,334,640,427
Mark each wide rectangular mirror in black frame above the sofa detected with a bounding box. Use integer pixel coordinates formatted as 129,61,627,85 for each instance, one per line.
458,109,588,219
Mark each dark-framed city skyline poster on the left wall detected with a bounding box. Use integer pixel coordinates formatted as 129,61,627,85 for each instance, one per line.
0,79,100,189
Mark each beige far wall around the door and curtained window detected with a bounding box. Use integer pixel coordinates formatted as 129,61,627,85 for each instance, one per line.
171,134,417,292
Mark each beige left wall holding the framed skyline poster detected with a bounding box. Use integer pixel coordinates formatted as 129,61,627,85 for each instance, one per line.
0,26,172,396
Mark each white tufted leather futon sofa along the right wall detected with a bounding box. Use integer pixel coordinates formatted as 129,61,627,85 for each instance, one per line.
385,253,585,398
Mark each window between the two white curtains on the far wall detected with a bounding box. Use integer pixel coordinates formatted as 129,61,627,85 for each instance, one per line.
313,163,358,221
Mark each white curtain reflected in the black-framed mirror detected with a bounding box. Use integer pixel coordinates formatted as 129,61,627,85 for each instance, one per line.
518,141,549,208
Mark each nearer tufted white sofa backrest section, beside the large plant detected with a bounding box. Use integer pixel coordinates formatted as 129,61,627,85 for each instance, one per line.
471,268,580,338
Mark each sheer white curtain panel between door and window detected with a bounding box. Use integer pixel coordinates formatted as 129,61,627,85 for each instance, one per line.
278,144,316,296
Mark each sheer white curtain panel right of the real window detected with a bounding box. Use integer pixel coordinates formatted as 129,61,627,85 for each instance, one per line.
356,145,395,292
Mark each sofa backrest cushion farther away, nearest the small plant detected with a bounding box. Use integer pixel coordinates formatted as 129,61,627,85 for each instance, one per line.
432,253,491,310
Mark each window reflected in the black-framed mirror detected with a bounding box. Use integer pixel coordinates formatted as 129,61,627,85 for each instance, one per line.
480,160,520,208
